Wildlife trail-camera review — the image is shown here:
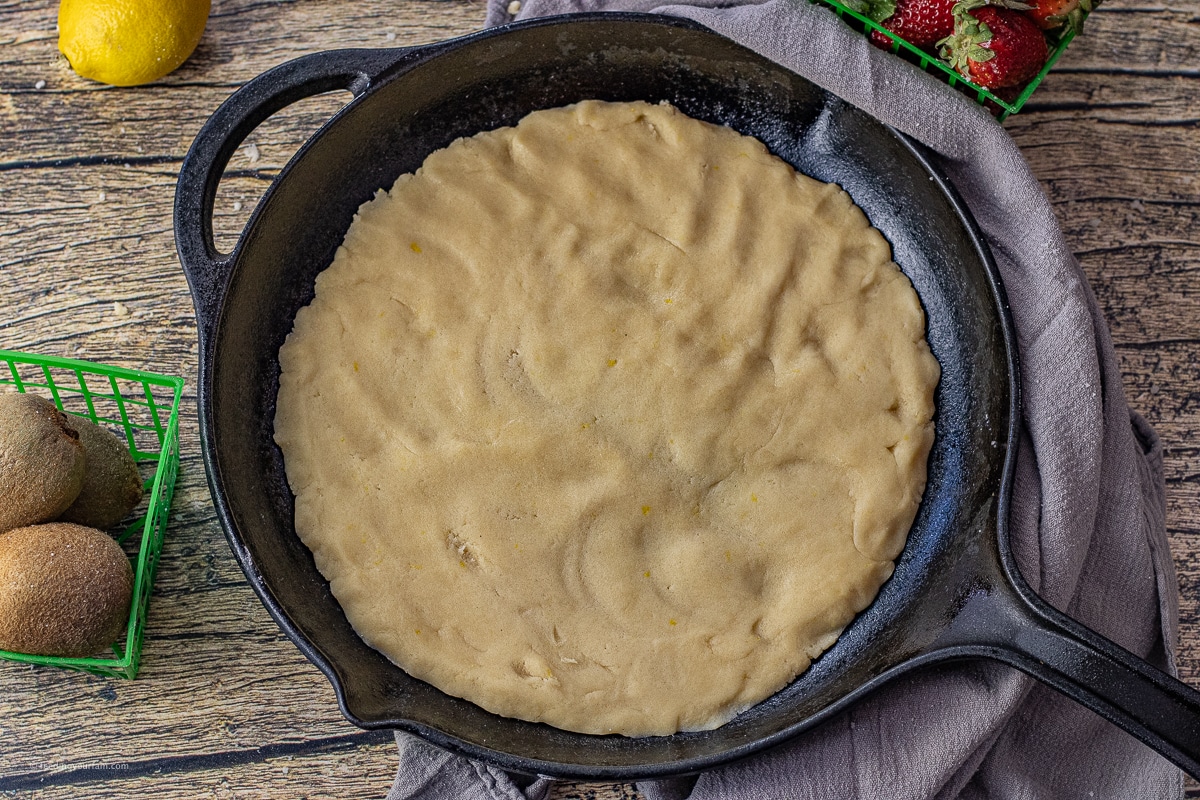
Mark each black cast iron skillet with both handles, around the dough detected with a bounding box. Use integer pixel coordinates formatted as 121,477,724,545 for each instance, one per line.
175,9,1200,780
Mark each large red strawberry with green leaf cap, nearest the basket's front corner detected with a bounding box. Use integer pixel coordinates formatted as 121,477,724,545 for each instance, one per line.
941,0,1050,89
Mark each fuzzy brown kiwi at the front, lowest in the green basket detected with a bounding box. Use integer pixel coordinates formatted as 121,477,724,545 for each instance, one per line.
0,522,133,657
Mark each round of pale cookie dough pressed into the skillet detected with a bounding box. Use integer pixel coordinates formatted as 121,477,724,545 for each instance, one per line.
275,102,938,735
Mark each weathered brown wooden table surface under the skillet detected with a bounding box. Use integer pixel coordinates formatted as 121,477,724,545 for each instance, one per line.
0,0,1200,799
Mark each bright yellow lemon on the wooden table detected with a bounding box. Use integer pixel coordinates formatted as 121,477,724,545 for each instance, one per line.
59,0,211,86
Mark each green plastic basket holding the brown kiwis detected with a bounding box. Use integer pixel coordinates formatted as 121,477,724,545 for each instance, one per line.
0,350,184,679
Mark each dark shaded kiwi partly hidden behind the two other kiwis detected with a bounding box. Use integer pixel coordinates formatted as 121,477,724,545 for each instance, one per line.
59,417,142,530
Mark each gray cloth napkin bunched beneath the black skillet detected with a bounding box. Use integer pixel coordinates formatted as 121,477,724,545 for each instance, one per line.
388,0,1183,800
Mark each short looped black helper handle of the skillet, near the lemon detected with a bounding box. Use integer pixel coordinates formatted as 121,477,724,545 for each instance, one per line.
175,48,414,347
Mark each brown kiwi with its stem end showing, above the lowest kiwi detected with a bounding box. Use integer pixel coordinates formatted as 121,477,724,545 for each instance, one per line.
0,392,86,531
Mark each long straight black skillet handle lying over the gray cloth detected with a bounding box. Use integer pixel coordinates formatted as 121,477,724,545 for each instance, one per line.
940,582,1200,777
